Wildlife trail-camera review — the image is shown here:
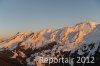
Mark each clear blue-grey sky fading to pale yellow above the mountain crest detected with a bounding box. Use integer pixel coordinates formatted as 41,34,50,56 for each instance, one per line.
0,0,100,36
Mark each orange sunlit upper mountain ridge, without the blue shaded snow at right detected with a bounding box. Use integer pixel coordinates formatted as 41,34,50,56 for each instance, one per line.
0,21,99,47
